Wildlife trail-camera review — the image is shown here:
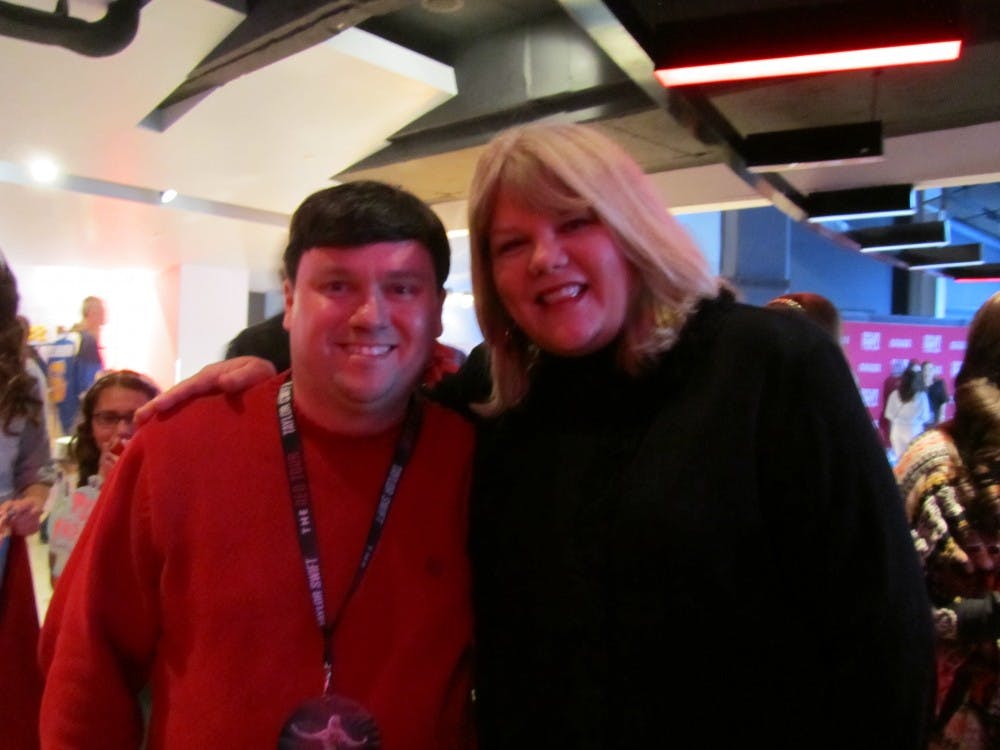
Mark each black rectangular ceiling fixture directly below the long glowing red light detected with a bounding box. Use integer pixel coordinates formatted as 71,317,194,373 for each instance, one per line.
740,122,882,172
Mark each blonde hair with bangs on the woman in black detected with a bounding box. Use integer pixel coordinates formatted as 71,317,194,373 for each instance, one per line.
469,124,719,415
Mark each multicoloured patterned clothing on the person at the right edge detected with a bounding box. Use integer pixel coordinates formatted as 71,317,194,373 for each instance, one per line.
896,424,1000,750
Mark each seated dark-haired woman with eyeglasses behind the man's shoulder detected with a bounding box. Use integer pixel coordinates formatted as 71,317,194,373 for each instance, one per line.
49,370,160,586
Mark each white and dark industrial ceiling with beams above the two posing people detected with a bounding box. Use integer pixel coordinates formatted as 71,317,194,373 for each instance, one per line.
0,0,1000,283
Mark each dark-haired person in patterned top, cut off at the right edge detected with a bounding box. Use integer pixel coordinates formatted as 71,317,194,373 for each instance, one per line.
896,293,1000,750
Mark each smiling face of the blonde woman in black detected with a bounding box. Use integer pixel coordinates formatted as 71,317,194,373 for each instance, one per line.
489,188,635,357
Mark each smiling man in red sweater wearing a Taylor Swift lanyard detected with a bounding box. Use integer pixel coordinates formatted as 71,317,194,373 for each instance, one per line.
41,182,473,750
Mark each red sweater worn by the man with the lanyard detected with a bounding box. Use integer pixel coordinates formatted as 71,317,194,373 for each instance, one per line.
41,377,473,750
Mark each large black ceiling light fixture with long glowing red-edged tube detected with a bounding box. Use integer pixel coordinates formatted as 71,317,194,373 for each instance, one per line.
648,0,962,87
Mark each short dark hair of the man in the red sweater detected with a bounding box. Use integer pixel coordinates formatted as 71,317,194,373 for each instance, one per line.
282,180,451,287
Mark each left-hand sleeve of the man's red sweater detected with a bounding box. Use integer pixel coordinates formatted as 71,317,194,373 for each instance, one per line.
39,433,162,750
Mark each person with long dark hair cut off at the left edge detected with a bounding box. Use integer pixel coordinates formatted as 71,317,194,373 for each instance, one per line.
0,257,54,750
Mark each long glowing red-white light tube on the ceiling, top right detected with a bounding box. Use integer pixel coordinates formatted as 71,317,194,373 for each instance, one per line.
654,39,962,88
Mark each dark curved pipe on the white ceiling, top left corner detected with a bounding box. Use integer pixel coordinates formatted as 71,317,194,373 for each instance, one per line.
0,0,144,57
